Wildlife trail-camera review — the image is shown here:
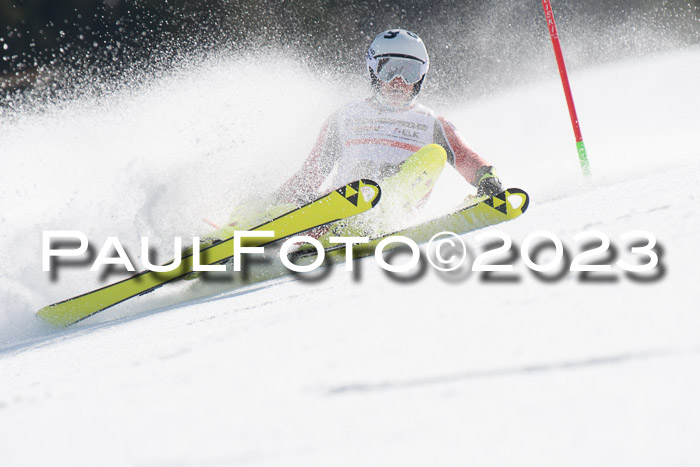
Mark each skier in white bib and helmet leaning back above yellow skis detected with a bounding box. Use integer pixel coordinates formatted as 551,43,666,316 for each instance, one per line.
277,29,502,203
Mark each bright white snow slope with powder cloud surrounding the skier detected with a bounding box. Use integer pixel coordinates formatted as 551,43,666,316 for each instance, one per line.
0,48,700,466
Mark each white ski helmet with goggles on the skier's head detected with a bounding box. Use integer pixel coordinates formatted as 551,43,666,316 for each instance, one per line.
367,29,430,97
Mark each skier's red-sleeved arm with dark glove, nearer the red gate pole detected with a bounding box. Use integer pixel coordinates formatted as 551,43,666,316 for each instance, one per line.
434,117,502,196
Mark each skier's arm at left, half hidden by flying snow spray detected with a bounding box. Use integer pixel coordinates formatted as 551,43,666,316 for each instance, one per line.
277,115,340,204
